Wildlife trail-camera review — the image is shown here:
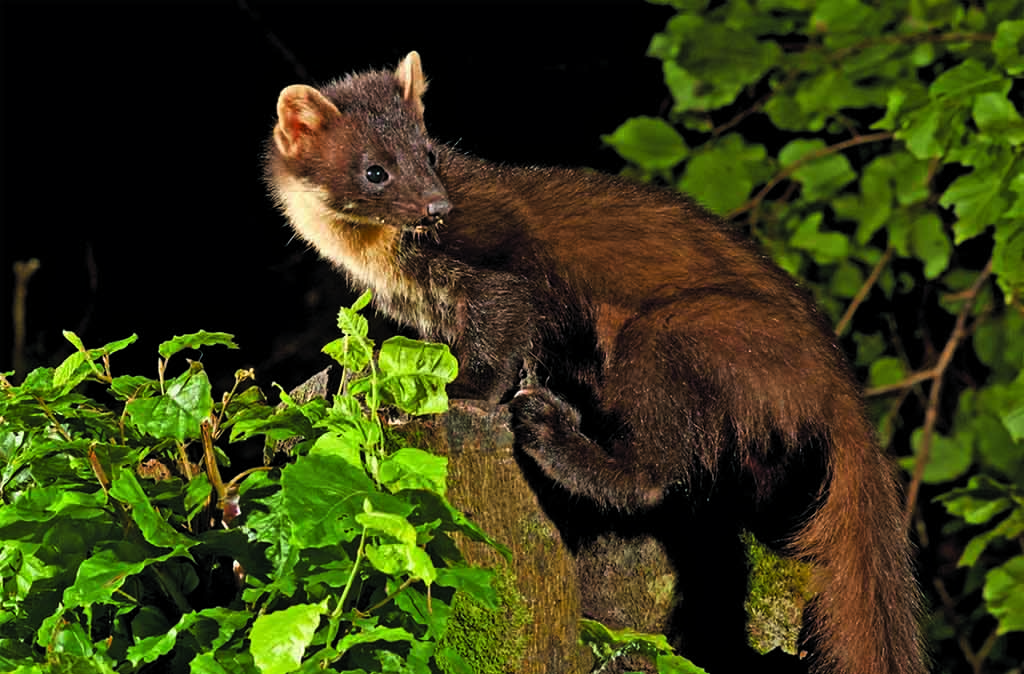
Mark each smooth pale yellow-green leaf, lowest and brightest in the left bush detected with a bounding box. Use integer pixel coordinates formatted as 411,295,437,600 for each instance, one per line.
249,604,325,674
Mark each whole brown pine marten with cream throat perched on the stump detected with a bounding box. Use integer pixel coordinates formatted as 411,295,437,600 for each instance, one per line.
265,51,926,674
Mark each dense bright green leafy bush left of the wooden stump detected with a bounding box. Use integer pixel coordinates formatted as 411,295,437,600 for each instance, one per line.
0,295,512,674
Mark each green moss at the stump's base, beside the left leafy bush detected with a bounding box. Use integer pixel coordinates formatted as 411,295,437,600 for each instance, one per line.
435,565,534,674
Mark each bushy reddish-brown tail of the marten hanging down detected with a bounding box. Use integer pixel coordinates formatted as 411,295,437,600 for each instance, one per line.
794,402,927,674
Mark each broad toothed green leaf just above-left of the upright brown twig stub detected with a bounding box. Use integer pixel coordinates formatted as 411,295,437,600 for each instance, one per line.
126,369,213,443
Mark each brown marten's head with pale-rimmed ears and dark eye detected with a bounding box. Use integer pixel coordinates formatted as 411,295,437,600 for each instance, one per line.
266,51,451,251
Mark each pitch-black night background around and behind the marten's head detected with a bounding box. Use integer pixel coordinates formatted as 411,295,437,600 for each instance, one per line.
0,0,672,388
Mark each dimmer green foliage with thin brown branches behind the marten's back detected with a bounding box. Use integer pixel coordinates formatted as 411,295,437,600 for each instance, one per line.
605,0,1024,672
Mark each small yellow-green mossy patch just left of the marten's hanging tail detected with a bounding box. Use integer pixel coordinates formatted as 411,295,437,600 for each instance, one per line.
741,532,813,655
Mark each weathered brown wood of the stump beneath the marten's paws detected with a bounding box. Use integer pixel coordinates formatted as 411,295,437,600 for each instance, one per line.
397,401,675,674
